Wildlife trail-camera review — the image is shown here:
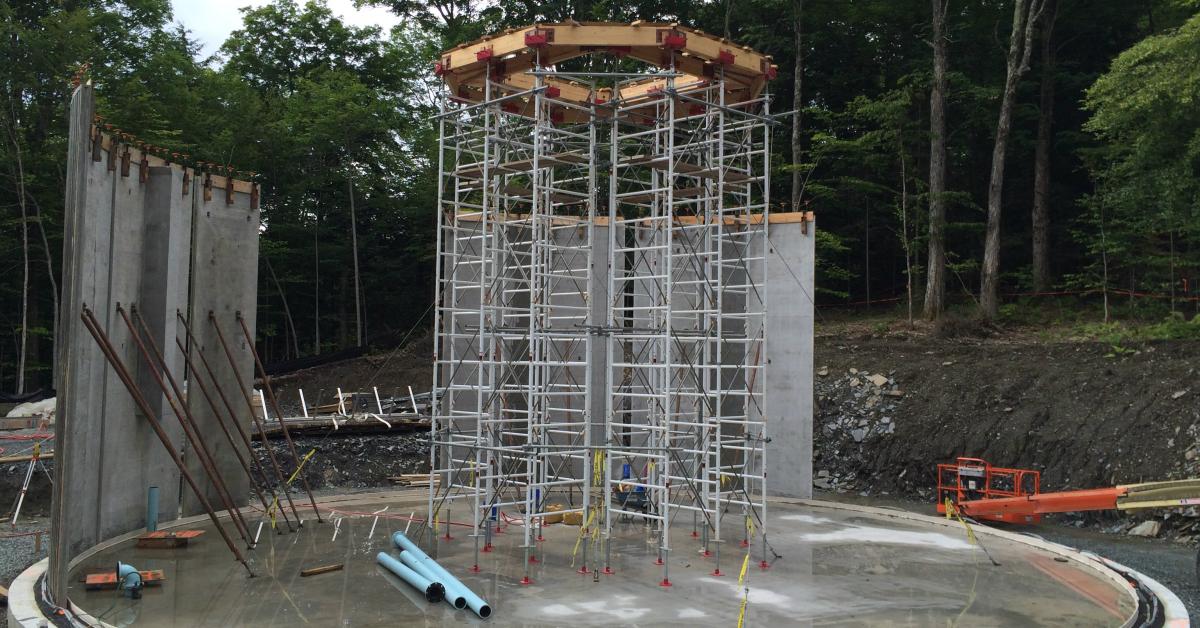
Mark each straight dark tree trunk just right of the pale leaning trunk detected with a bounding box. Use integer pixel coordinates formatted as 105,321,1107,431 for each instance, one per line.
1032,0,1057,292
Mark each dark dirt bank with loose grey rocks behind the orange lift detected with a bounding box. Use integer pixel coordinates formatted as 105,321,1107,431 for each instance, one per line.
814,337,1200,506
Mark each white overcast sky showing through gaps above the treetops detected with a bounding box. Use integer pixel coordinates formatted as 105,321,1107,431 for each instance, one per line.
170,0,400,56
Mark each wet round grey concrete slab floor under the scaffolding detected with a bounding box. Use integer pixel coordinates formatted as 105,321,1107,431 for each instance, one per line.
71,498,1134,627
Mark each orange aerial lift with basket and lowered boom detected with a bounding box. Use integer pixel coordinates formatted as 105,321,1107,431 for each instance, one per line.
937,457,1200,524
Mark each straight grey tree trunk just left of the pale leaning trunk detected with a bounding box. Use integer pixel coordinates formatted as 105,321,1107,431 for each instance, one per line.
924,0,949,321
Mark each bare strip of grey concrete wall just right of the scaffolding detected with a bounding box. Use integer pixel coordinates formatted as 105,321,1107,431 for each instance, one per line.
764,221,816,498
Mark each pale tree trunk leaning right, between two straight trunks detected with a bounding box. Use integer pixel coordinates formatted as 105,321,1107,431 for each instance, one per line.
979,0,1043,321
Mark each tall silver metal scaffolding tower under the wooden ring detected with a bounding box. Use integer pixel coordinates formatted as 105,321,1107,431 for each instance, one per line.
428,22,772,585
